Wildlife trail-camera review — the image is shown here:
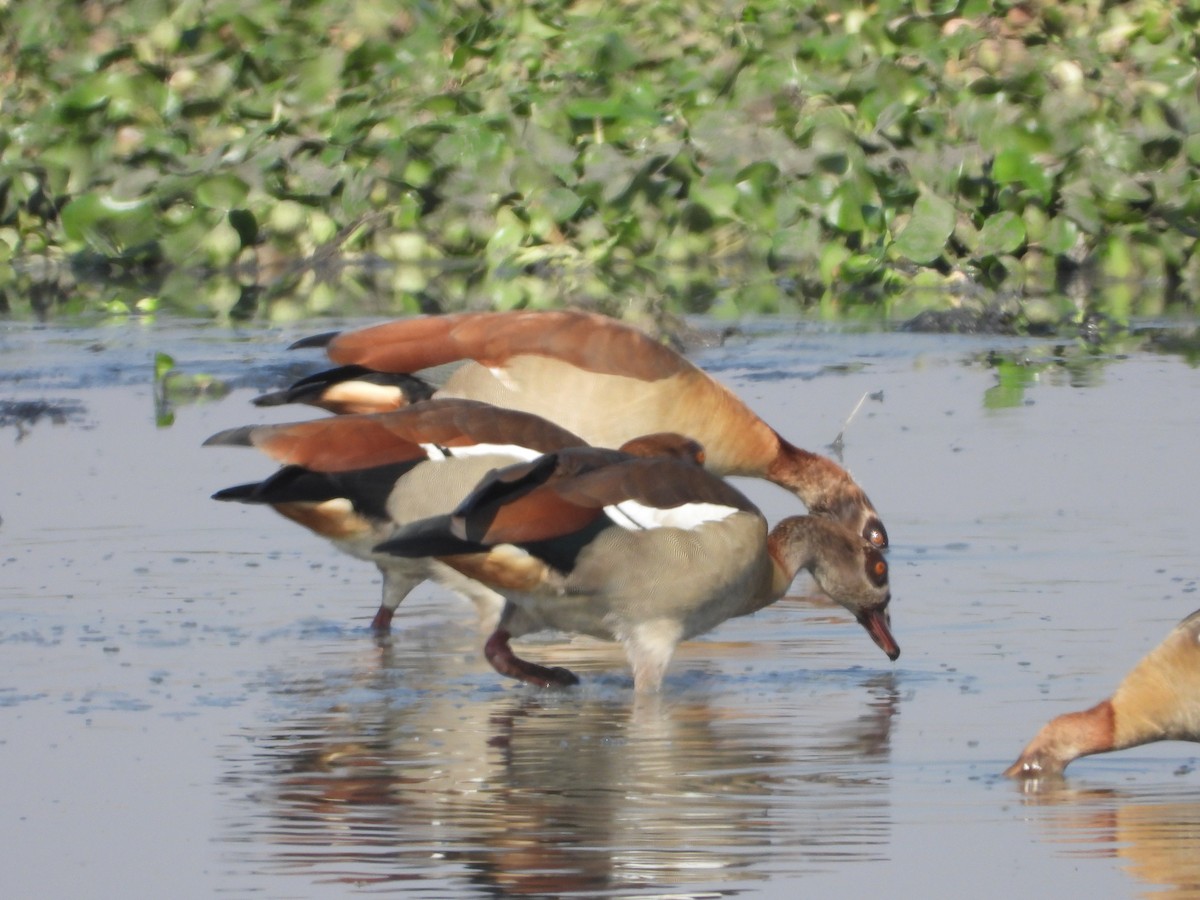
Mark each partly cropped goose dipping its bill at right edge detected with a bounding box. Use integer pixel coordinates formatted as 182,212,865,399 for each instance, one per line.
1004,610,1200,779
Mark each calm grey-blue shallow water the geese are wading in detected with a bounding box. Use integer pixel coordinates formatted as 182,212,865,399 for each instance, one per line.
0,323,1200,898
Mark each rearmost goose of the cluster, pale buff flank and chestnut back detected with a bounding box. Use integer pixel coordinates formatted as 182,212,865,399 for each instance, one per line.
274,311,888,547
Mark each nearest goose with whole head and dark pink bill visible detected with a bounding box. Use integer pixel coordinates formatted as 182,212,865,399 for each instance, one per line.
377,448,900,691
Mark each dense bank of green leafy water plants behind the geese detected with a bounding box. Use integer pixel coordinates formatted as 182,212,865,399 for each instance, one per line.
0,0,1200,318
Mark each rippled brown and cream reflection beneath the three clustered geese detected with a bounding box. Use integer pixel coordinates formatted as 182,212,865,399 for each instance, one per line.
220,642,899,895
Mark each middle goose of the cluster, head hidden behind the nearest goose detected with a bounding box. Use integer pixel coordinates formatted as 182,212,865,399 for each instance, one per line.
205,398,702,631
